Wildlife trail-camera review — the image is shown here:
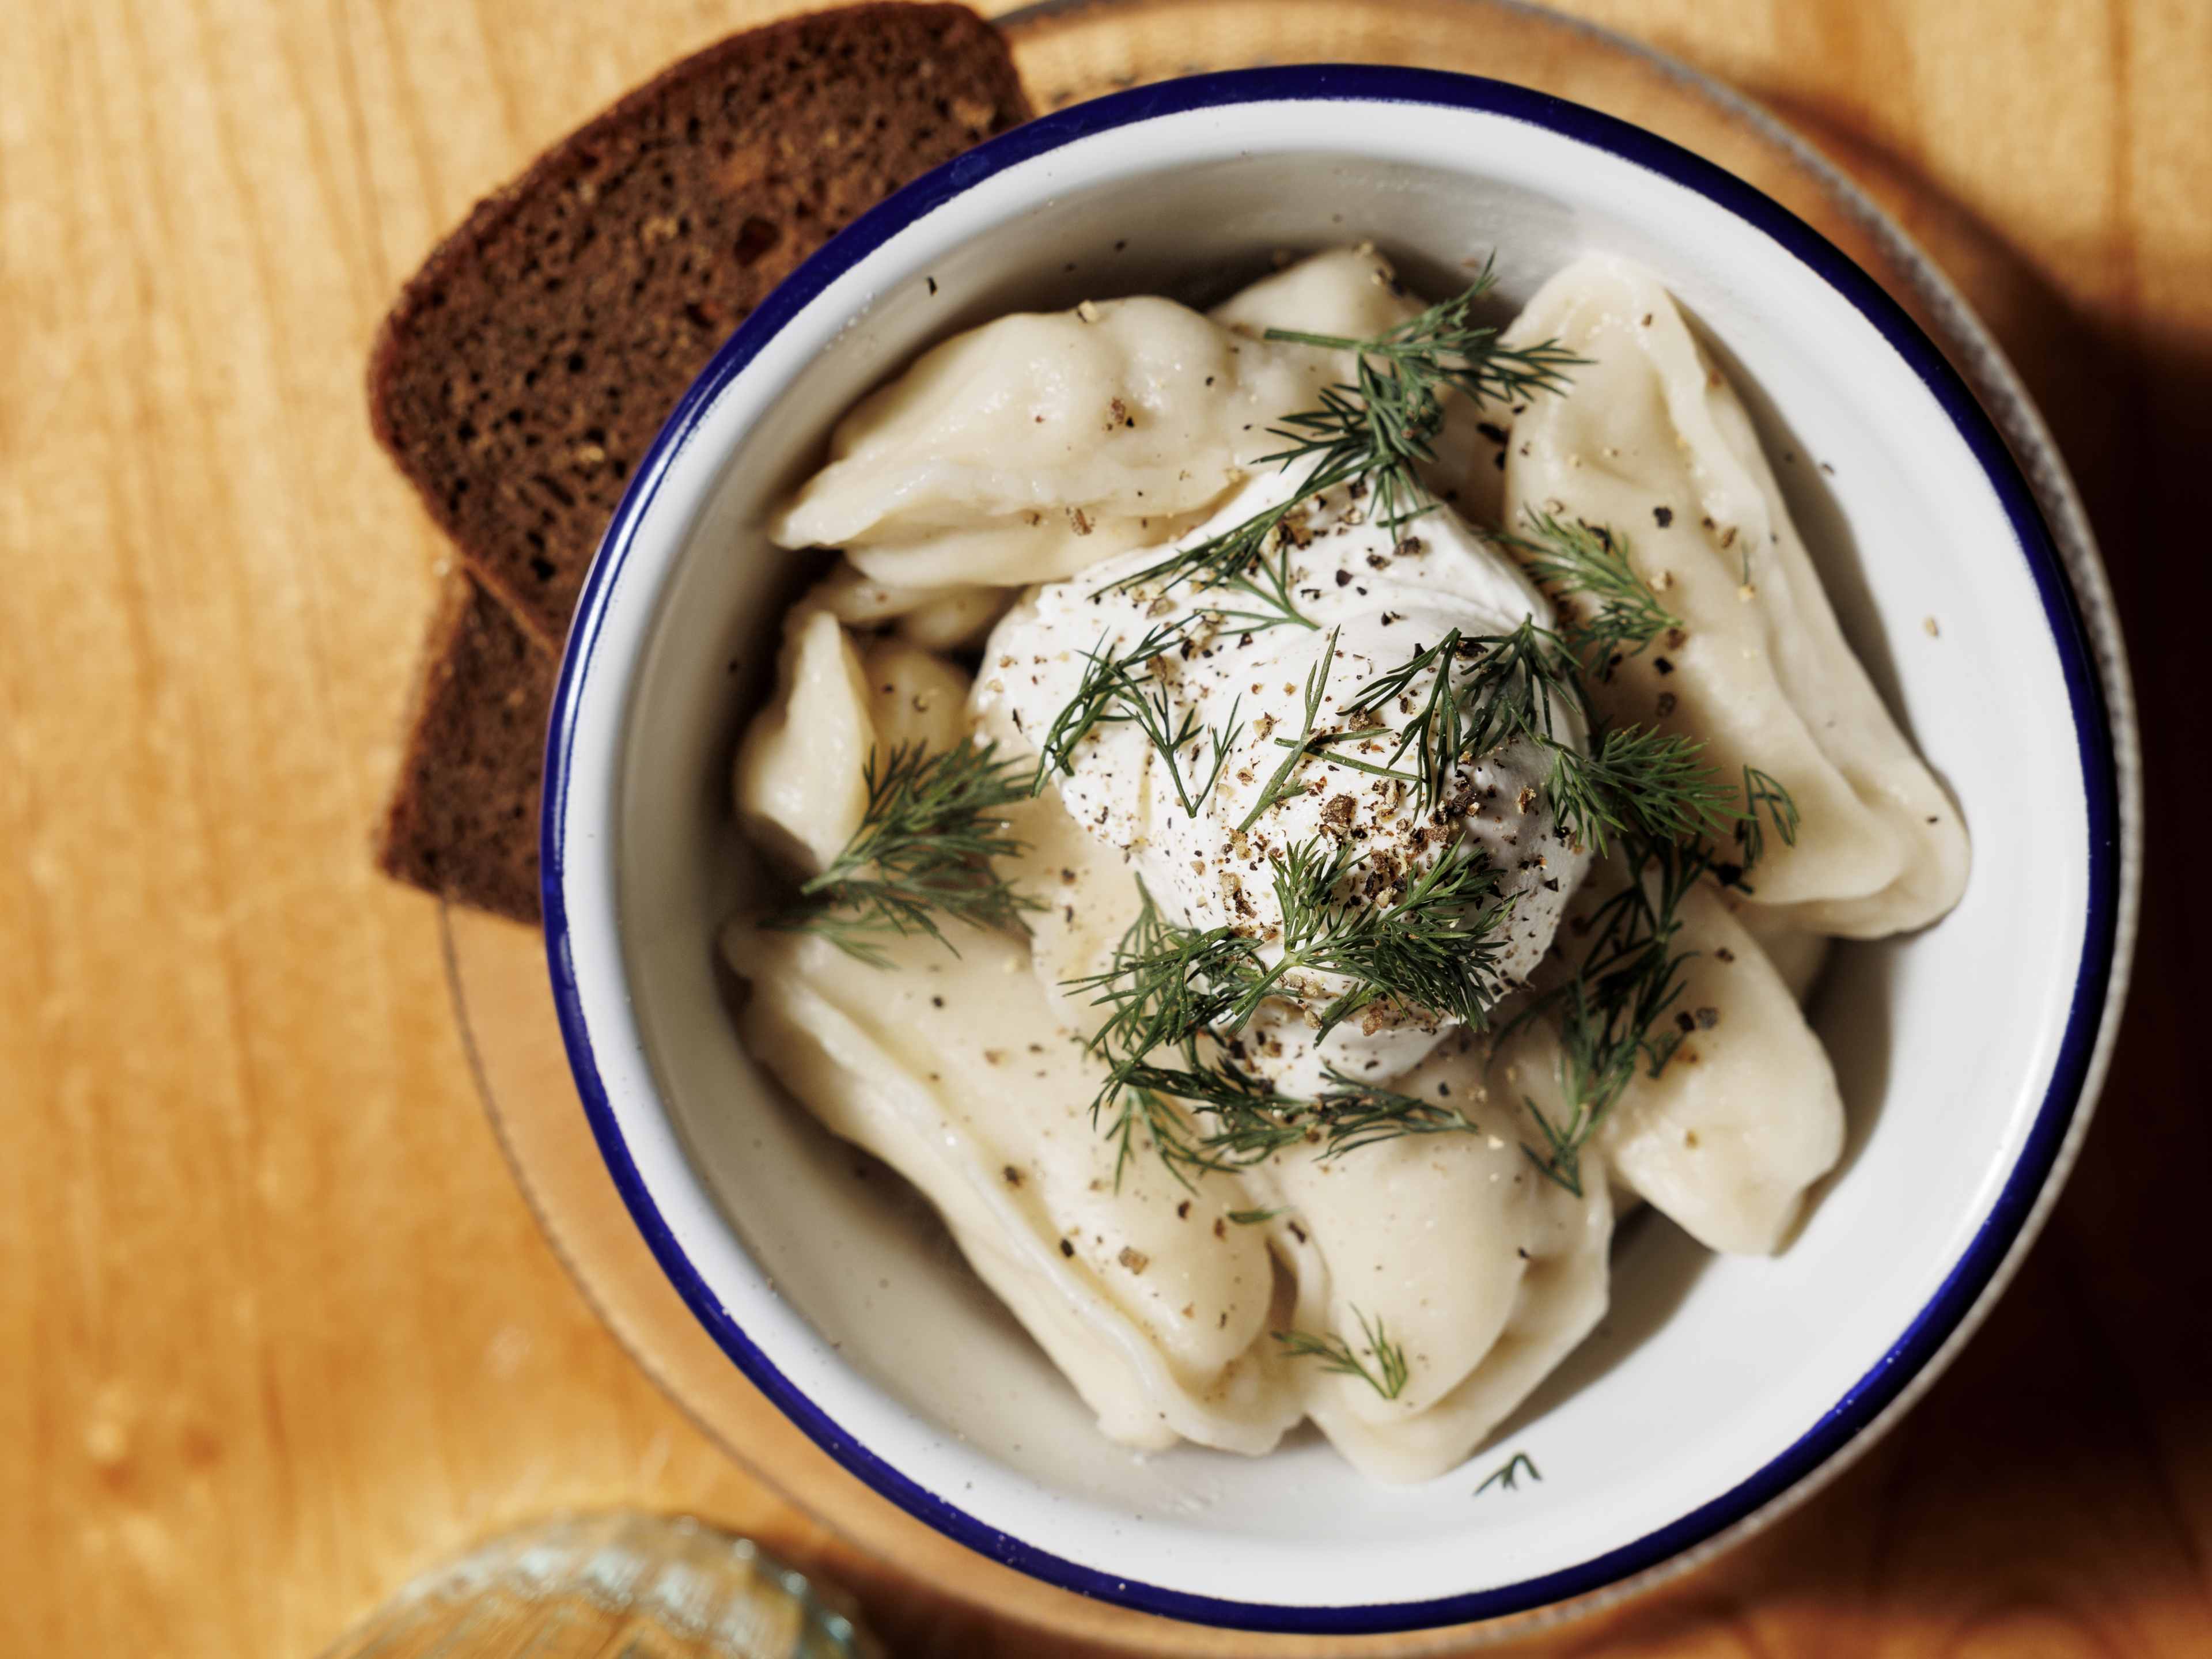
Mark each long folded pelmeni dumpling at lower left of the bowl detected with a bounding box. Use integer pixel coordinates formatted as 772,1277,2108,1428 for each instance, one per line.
728,925,1303,1453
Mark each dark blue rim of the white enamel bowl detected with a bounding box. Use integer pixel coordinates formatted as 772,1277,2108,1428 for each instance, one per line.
542,64,2122,1635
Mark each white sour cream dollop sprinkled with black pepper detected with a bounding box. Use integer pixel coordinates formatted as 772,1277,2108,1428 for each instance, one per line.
974,471,1588,1095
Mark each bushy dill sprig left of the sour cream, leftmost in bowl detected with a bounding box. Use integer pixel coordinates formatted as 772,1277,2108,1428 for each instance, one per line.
767,739,1040,967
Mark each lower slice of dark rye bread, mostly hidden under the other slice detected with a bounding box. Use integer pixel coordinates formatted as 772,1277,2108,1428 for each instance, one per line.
376,571,555,925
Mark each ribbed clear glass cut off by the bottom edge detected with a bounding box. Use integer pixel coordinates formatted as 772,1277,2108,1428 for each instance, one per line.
323,1513,882,1659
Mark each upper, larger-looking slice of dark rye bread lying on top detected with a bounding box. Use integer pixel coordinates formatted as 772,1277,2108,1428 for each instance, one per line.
369,5,1029,648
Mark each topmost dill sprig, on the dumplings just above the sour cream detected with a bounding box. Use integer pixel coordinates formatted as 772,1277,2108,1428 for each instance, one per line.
1263,259,1584,524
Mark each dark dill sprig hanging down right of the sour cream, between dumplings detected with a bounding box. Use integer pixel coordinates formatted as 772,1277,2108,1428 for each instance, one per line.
1520,836,1712,1196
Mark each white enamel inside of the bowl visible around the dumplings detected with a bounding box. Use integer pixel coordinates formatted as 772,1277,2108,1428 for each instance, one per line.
560,102,2088,1606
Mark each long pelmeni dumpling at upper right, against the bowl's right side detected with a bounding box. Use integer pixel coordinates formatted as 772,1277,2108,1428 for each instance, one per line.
1506,255,1967,938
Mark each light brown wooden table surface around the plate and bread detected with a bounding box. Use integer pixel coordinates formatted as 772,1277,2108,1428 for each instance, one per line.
0,0,2212,1659
